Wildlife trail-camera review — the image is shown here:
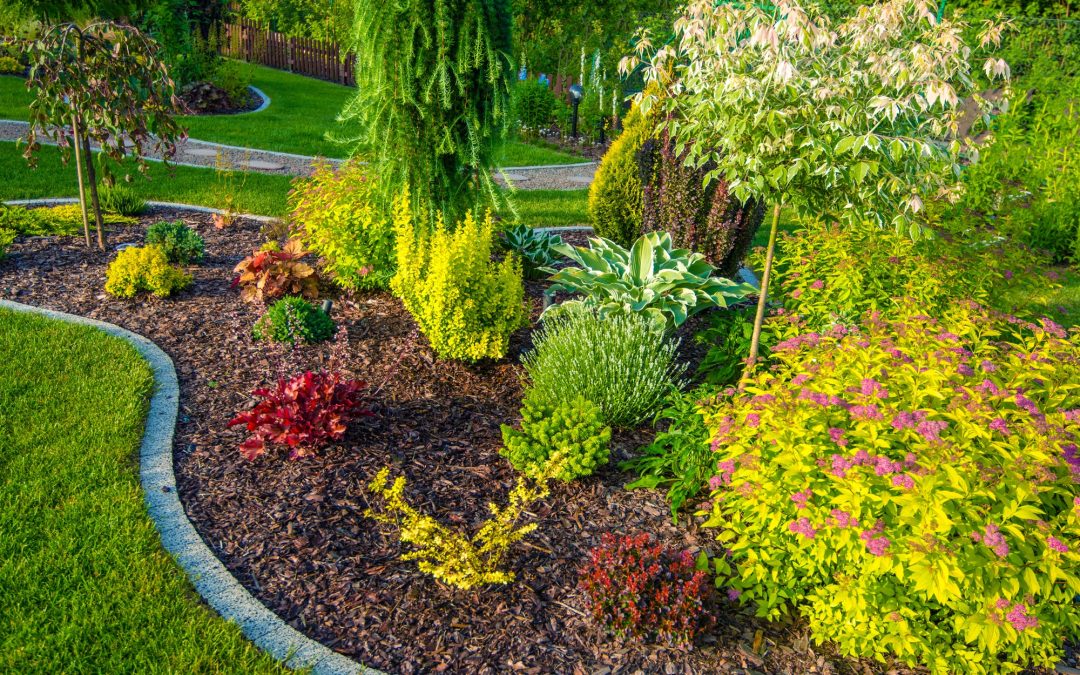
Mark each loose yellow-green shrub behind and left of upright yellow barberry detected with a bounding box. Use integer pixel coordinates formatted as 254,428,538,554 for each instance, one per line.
288,162,394,289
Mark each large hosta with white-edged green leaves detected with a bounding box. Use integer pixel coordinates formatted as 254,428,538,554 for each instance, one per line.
548,232,754,330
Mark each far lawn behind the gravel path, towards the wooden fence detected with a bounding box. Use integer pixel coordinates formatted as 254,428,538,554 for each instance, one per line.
0,69,584,166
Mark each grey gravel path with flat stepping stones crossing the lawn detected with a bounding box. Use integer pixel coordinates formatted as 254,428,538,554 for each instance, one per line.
0,120,596,190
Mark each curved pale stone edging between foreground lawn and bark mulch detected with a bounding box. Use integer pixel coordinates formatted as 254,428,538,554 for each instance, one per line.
0,298,384,675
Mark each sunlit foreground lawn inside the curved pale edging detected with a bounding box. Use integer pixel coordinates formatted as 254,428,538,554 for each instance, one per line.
0,310,284,673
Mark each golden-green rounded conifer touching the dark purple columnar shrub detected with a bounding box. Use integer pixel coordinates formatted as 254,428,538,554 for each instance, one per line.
589,101,652,246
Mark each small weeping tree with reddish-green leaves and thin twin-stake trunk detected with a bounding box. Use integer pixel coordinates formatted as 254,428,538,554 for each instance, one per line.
24,22,185,249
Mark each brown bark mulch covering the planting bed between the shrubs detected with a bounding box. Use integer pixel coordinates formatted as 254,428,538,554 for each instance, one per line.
0,211,877,674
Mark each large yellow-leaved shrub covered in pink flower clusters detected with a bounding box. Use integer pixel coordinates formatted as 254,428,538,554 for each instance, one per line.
703,302,1080,674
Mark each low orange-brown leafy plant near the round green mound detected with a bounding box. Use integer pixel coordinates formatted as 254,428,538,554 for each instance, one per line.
233,239,319,302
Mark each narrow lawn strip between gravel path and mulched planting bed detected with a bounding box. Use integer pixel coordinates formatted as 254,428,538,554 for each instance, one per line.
0,143,589,227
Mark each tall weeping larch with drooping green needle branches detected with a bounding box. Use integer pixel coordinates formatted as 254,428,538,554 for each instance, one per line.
340,0,512,222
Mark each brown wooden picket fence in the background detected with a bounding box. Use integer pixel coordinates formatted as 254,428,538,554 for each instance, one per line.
218,17,356,86
